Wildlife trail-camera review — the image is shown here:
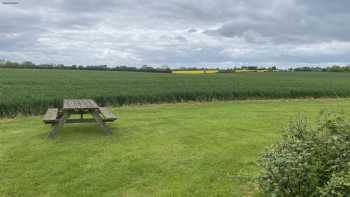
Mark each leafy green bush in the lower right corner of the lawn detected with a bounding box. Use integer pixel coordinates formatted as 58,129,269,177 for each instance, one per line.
258,112,350,197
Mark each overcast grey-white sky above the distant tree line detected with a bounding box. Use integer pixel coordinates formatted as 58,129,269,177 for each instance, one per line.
0,0,350,67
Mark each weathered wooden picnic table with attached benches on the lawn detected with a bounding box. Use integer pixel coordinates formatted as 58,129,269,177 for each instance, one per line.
43,99,117,138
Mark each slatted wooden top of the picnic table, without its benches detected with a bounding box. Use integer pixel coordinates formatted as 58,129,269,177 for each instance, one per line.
63,99,99,110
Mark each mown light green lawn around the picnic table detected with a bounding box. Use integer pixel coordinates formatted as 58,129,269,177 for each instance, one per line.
0,99,350,197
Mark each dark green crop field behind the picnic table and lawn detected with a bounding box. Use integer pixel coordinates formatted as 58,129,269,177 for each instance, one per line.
0,69,350,117
